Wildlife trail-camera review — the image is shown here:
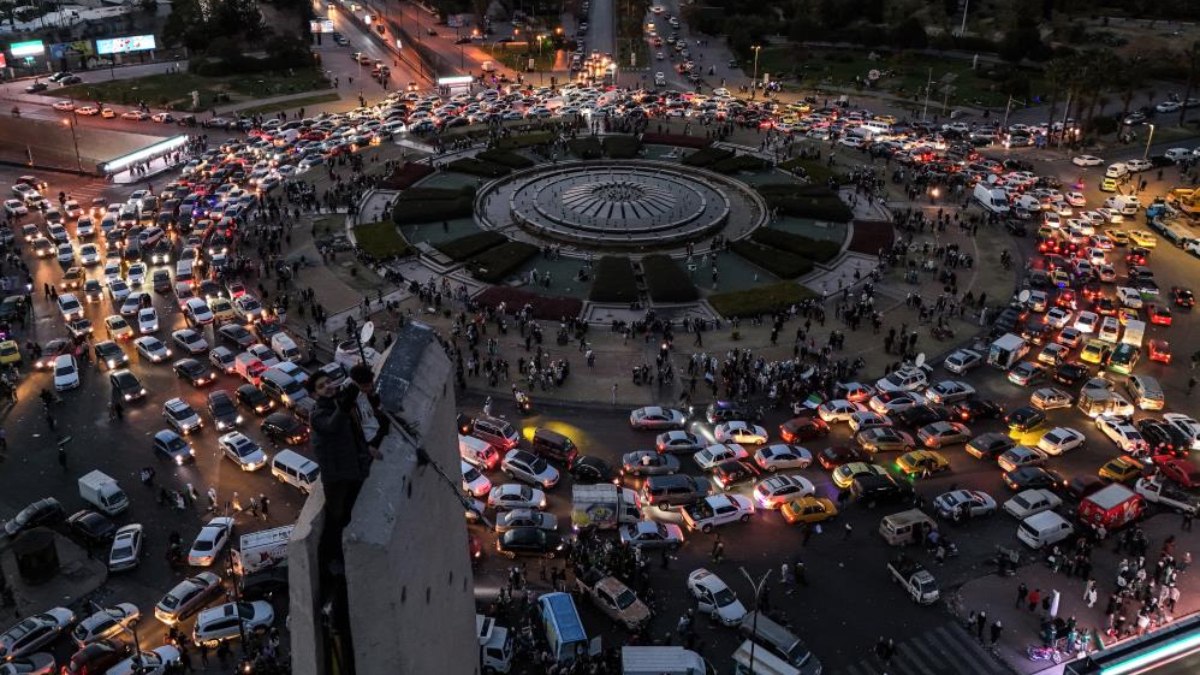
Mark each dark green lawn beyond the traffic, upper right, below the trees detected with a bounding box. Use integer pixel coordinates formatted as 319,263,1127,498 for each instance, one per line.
758,46,1045,108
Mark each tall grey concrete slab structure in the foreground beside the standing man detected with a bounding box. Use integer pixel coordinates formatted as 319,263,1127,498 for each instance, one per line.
290,324,479,675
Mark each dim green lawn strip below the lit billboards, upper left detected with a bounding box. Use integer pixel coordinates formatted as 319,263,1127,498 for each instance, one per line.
54,70,329,110
